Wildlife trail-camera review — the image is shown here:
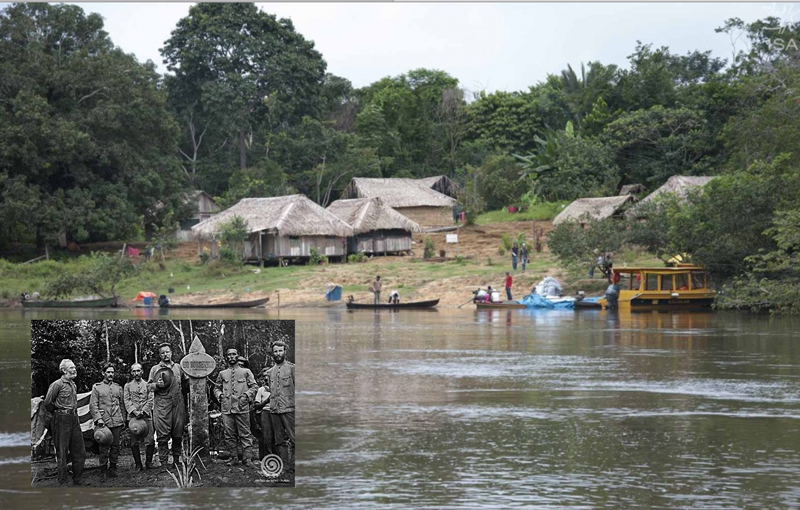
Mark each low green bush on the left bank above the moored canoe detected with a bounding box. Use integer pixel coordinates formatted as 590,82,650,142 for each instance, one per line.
45,252,138,298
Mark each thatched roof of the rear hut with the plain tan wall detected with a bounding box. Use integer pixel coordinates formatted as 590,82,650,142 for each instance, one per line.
342,177,456,207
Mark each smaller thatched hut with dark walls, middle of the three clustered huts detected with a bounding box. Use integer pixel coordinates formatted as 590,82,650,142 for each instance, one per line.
328,198,422,255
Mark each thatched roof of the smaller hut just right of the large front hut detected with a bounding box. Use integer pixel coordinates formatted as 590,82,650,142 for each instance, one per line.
328,198,422,234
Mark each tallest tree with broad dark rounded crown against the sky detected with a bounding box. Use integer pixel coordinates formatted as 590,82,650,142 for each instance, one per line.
161,3,326,177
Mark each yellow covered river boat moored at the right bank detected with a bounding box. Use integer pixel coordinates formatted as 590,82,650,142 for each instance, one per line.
598,264,716,311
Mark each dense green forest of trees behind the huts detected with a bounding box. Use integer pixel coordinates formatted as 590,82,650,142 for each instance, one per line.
0,3,800,310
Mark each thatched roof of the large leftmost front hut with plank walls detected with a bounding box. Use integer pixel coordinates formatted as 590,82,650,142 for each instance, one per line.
192,195,353,238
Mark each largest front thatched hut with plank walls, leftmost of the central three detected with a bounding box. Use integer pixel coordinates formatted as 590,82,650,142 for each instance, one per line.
192,195,353,262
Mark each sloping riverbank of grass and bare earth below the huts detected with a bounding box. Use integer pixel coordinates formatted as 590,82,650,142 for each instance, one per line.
0,221,658,308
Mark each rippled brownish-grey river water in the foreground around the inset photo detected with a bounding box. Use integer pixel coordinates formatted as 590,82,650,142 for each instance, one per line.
0,309,800,510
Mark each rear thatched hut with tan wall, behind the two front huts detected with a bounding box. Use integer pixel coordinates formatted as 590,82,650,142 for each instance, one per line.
342,177,457,229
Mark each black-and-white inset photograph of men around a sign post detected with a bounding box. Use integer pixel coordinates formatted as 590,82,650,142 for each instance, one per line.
31,320,295,487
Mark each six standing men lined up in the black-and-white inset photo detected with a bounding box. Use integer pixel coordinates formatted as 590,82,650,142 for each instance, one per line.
43,341,294,485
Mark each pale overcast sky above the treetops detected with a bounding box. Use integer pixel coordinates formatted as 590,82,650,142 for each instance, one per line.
73,2,788,92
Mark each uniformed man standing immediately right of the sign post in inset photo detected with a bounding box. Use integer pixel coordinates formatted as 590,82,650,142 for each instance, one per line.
214,348,258,465
